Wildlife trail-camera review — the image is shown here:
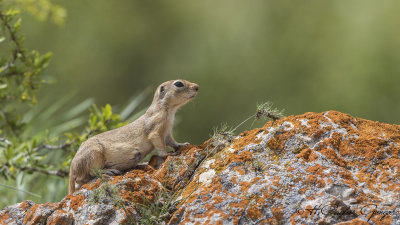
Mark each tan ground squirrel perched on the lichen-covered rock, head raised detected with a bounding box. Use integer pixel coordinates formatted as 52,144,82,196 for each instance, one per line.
69,80,199,194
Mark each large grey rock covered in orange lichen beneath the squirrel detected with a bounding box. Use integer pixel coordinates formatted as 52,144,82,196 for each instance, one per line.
0,111,400,225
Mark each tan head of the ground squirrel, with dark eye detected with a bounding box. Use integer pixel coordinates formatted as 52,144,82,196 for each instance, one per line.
153,79,199,108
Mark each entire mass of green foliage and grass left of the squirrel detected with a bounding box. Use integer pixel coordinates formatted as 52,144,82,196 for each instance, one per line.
0,0,145,208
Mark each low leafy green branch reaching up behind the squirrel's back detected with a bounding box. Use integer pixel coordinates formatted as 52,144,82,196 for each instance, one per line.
0,105,124,179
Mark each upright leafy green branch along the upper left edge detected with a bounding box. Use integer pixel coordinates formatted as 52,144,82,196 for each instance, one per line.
0,9,51,136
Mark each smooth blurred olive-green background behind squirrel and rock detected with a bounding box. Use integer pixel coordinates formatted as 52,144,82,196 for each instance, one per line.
0,0,400,207
